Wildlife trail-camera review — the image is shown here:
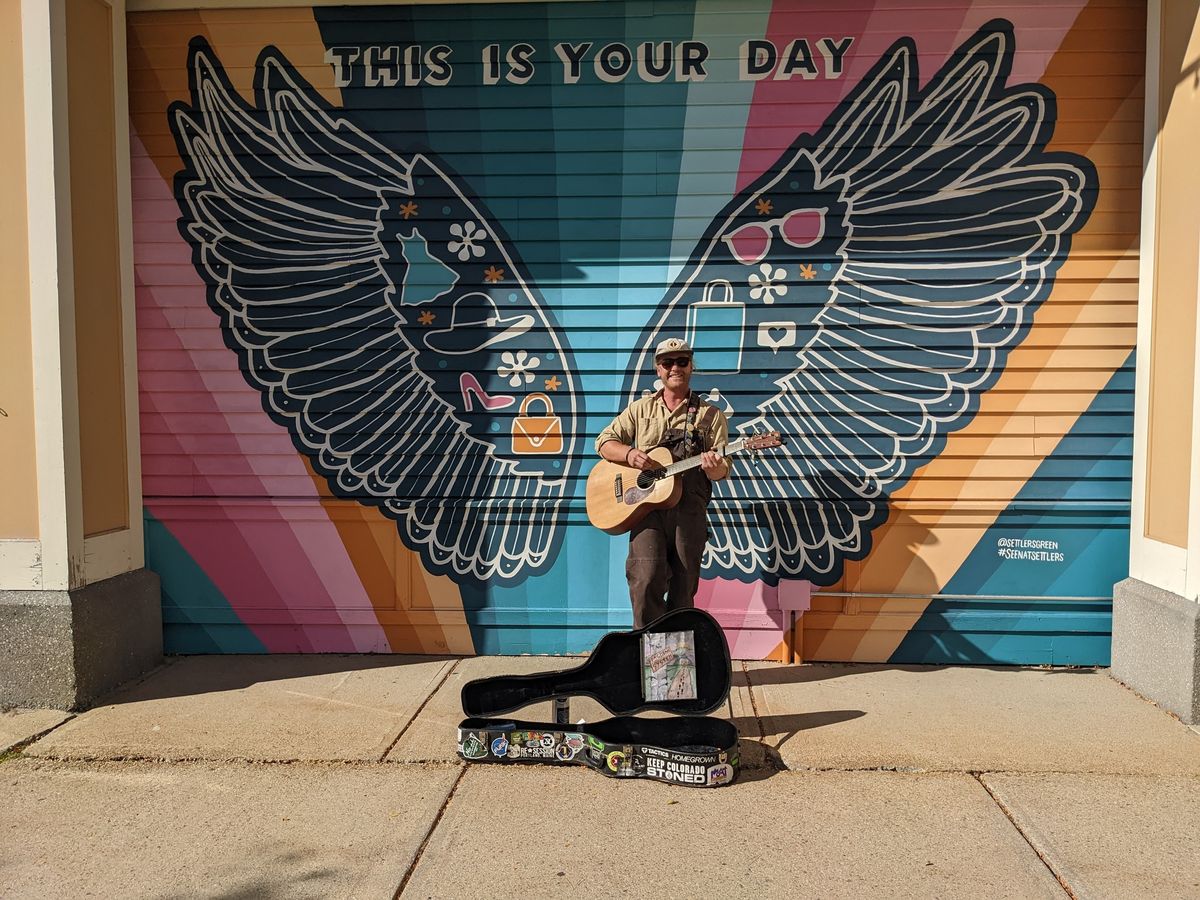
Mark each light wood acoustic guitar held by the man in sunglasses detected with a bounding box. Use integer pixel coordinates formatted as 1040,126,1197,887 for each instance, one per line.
587,431,784,534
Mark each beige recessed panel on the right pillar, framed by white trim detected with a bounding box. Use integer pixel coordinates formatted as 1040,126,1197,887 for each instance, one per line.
1145,0,1200,547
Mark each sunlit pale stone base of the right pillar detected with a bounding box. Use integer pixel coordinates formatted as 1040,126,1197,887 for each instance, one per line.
1111,578,1200,725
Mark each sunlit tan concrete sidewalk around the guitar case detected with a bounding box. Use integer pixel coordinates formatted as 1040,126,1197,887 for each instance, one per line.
0,656,1200,898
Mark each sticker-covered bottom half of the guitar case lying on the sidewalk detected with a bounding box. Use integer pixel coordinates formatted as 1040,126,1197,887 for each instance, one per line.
458,716,740,787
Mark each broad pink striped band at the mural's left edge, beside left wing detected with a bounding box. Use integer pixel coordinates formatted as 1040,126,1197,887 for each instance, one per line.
132,136,390,653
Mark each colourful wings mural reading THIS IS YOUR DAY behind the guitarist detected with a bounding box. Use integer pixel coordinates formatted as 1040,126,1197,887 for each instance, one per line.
130,0,1141,662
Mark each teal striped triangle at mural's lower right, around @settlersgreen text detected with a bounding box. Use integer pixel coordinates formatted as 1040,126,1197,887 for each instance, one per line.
889,354,1134,666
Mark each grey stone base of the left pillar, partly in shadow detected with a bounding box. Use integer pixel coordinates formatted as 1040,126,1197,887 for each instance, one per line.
0,569,162,709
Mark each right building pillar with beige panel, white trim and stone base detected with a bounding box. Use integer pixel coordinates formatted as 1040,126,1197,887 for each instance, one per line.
1111,0,1200,724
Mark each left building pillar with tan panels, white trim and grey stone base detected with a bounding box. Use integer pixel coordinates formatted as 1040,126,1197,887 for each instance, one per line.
0,0,162,709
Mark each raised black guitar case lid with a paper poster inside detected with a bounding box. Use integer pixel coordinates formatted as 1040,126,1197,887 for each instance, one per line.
462,608,732,718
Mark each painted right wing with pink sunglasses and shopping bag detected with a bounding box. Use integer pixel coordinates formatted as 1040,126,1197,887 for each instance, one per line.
629,22,1096,584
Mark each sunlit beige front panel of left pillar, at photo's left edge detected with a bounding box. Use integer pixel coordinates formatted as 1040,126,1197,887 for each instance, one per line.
0,1,38,539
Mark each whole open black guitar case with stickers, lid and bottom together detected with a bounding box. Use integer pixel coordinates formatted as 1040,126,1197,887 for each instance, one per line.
458,610,739,787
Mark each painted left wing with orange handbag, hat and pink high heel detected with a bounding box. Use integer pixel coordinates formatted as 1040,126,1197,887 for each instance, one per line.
169,41,576,581
